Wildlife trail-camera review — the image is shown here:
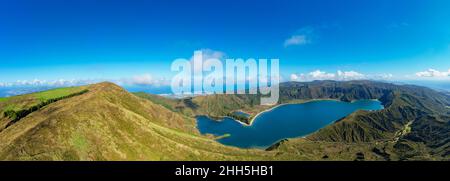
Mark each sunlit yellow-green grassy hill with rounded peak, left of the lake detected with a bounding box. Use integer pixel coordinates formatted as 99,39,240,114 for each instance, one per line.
0,83,273,160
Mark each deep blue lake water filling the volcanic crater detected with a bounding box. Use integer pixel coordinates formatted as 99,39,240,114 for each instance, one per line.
197,100,383,148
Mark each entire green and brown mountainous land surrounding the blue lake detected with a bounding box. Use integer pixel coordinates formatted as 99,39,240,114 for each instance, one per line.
0,81,450,160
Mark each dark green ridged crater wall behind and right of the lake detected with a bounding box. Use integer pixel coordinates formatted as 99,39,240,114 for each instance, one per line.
274,81,450,159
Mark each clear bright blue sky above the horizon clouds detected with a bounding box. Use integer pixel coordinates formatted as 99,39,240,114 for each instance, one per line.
0,0,450,87
